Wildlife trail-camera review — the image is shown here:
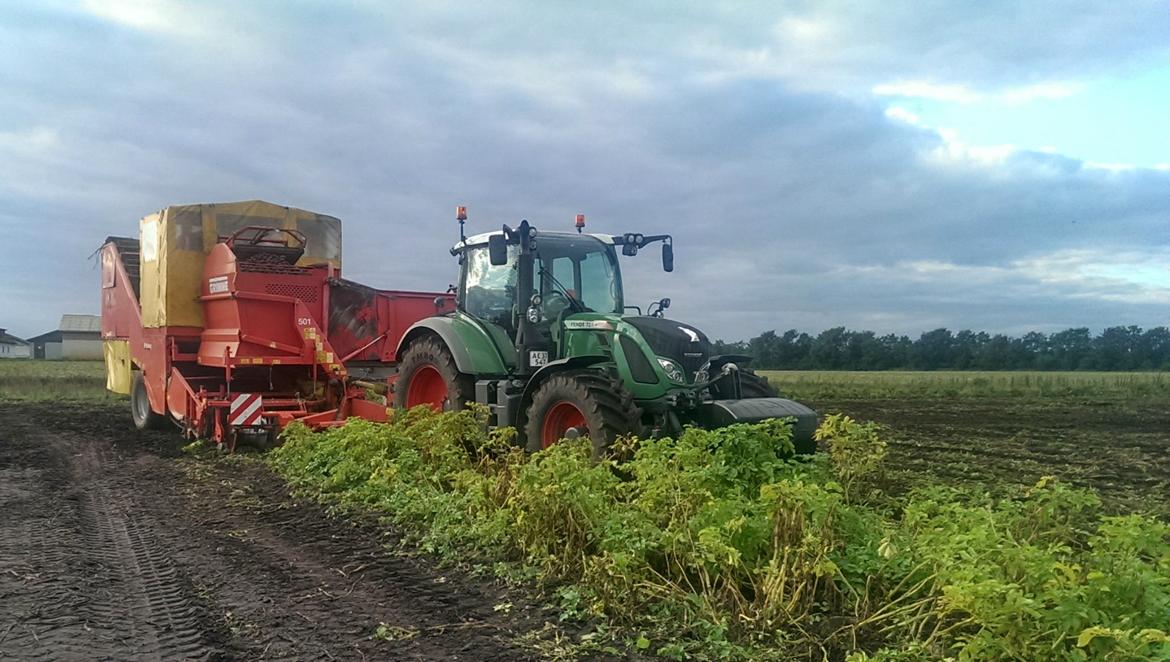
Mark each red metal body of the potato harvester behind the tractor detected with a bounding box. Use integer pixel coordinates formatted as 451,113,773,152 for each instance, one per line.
102,228,454,449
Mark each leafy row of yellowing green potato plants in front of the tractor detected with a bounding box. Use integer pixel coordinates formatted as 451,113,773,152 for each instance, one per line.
270,408,1170,662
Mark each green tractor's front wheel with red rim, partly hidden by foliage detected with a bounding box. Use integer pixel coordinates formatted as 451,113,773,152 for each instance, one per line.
524,371,642,460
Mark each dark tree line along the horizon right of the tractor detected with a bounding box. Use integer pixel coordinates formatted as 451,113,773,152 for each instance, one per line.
714,326,1170,371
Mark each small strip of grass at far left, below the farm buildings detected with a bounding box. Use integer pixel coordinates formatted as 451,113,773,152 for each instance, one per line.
0,359,124,402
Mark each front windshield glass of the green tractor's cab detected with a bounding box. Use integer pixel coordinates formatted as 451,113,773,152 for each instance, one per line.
536,235,622,313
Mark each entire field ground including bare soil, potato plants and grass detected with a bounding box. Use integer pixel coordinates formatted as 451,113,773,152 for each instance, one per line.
0,361,1170,661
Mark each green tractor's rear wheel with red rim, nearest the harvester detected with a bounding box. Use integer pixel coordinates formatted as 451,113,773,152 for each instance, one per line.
394,337,475,412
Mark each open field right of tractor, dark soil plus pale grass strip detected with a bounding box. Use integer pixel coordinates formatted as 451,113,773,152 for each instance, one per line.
766,372,1170,516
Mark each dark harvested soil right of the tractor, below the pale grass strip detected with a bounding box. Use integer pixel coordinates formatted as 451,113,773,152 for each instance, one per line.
811,398,1170,518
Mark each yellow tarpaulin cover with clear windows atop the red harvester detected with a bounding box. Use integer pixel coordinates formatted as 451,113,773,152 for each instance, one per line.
139,200,342,329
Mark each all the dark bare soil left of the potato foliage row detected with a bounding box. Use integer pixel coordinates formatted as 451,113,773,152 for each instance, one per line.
0,404,549,661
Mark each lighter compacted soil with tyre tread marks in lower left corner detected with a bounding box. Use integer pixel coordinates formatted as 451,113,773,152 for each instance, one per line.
0,418,218,660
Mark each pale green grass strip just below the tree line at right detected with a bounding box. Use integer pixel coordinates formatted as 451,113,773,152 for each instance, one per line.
761,371,1170,400
